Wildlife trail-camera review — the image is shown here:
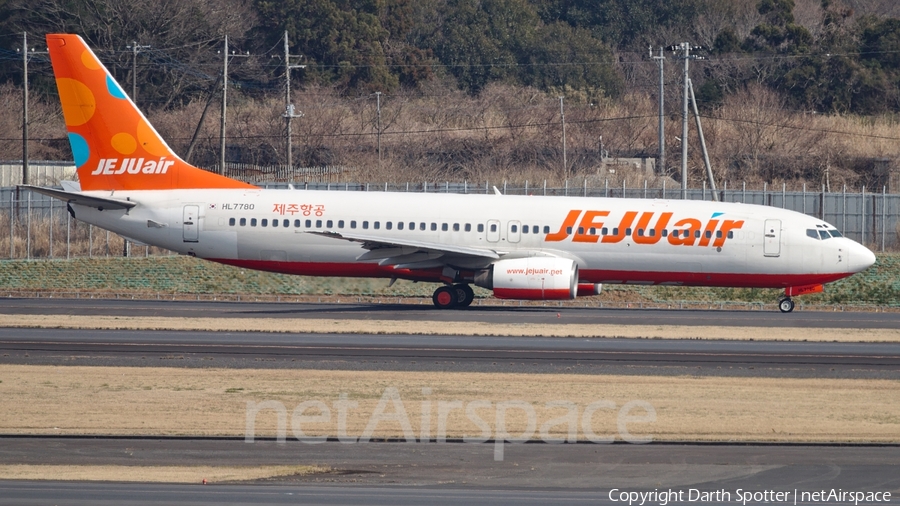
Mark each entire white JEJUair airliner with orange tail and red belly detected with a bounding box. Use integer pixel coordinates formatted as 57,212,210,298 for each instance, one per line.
22,35,875,312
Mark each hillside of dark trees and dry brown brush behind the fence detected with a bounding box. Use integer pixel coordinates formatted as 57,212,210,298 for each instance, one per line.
0,0,900,190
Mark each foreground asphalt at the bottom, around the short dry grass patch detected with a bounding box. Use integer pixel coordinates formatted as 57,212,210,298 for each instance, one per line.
0,438,900,505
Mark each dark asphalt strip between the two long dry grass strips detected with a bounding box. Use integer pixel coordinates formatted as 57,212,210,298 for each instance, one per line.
0,328,900,377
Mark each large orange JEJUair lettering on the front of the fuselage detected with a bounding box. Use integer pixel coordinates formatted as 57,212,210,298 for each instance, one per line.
544,209,744,247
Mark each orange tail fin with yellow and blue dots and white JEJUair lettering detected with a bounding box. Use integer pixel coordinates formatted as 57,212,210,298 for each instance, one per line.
47,34,253,190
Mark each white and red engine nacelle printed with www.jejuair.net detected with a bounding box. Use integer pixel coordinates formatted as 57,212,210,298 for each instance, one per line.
475,257,578,300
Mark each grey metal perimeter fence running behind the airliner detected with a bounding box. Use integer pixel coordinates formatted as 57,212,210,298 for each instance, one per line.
0,179,900,259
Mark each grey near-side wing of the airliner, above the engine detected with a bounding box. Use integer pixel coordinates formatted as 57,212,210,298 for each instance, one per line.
306,231,500,269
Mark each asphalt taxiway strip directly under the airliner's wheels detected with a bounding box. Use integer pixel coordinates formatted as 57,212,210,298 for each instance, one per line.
0,298,900,330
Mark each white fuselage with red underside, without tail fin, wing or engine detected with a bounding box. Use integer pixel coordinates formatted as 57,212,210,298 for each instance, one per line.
73,189,874,288
